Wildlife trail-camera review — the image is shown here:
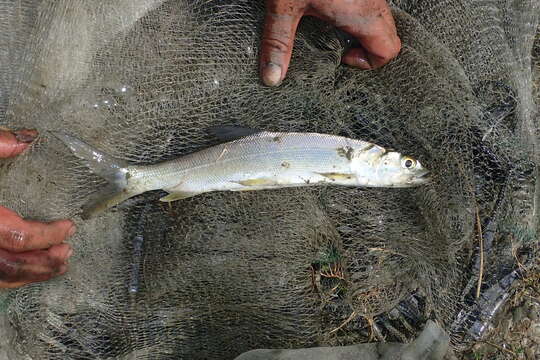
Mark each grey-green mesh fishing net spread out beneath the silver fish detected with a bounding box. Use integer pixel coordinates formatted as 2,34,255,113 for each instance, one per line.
0,0,540,359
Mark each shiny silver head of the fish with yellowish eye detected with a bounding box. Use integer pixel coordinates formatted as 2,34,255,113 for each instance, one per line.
375,151,430,187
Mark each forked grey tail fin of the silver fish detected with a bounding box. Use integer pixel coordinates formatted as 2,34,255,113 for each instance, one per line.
53,133,141,219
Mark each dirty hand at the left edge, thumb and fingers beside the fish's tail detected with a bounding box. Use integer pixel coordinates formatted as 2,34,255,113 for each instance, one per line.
0,130,75,288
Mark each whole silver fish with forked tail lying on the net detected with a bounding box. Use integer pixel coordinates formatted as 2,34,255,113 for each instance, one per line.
55,127,429,218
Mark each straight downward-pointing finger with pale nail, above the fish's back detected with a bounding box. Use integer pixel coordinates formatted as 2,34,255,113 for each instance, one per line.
260,0,305,86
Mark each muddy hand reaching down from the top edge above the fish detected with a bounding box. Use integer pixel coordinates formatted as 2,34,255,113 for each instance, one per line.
260,0,401,86
